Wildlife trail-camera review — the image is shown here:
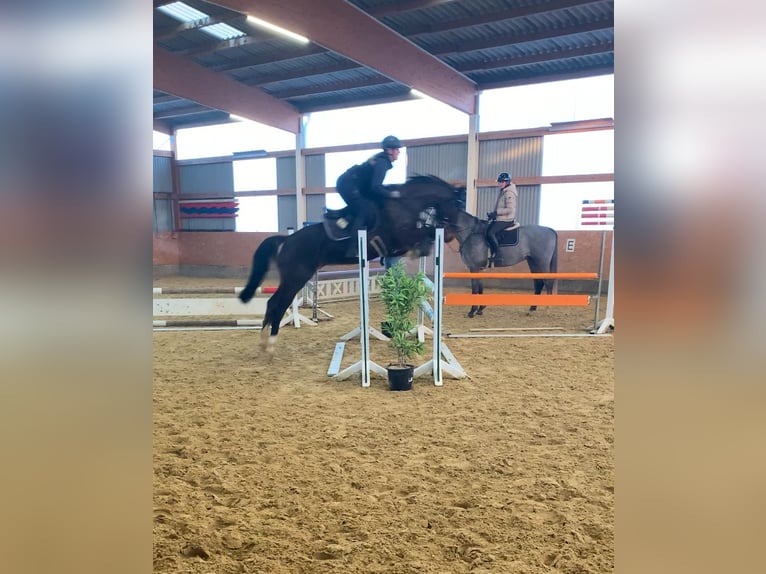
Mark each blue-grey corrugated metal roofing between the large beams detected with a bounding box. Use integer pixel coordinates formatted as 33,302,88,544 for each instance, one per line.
154,0,614,127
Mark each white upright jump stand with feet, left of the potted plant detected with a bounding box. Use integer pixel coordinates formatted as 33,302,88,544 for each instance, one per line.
328,229,388,387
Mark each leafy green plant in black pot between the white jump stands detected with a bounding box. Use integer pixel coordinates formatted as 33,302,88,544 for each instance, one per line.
378,260,428,391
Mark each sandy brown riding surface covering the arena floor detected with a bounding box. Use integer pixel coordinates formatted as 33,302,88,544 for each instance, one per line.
154,278,614,574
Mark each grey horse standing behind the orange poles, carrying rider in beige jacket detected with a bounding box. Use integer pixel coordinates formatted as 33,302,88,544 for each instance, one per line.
453,211,558,318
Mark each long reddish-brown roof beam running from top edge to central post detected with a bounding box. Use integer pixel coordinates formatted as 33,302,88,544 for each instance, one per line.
207,0,476,114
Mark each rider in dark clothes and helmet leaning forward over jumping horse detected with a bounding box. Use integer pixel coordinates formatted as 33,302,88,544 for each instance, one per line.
336,136,402,257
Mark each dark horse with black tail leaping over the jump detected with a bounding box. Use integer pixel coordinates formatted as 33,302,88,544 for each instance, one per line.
239,176,460,353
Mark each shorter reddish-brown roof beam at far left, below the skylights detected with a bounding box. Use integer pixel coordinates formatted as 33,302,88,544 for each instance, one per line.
154,44,300,133
